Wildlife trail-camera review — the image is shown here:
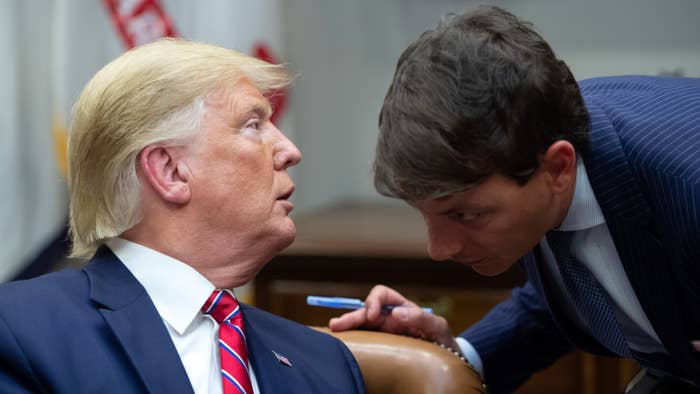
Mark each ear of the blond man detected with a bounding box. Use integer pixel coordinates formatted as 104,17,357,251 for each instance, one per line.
139,145,191,204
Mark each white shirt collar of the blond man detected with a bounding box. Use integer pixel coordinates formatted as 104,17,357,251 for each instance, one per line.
106,238,215,335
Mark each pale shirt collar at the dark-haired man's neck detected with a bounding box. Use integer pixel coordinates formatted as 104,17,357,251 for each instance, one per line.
557,157,605,231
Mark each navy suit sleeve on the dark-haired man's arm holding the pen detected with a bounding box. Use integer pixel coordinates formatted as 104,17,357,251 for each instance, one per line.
460,281,573,394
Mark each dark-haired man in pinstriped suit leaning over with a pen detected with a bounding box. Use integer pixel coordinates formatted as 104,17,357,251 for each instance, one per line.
330,7,700,393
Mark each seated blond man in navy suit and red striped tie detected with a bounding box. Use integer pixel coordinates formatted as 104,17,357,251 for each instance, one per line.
0,39,364,394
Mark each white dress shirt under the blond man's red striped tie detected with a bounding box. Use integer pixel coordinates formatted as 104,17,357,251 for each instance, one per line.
102,238,260,394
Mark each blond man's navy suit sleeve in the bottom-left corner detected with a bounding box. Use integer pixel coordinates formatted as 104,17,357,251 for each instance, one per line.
0,316,44,393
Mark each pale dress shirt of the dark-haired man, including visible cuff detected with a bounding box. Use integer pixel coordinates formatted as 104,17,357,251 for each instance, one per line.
456,158,666,378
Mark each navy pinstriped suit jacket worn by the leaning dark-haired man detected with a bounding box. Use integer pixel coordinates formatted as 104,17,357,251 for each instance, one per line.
461,76,700,393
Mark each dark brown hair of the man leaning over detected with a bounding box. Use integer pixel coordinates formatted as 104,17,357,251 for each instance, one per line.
374,7,589,201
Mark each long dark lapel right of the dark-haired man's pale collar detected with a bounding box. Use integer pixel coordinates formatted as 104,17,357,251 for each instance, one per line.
583,103,698,376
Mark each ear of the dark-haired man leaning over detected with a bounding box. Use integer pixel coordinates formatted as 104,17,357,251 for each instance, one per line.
541,140,576,193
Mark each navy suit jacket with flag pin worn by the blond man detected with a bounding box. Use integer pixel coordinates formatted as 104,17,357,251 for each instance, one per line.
0,247,364,394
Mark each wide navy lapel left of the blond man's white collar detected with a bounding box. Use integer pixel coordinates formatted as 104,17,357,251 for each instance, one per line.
84,246,193,394
